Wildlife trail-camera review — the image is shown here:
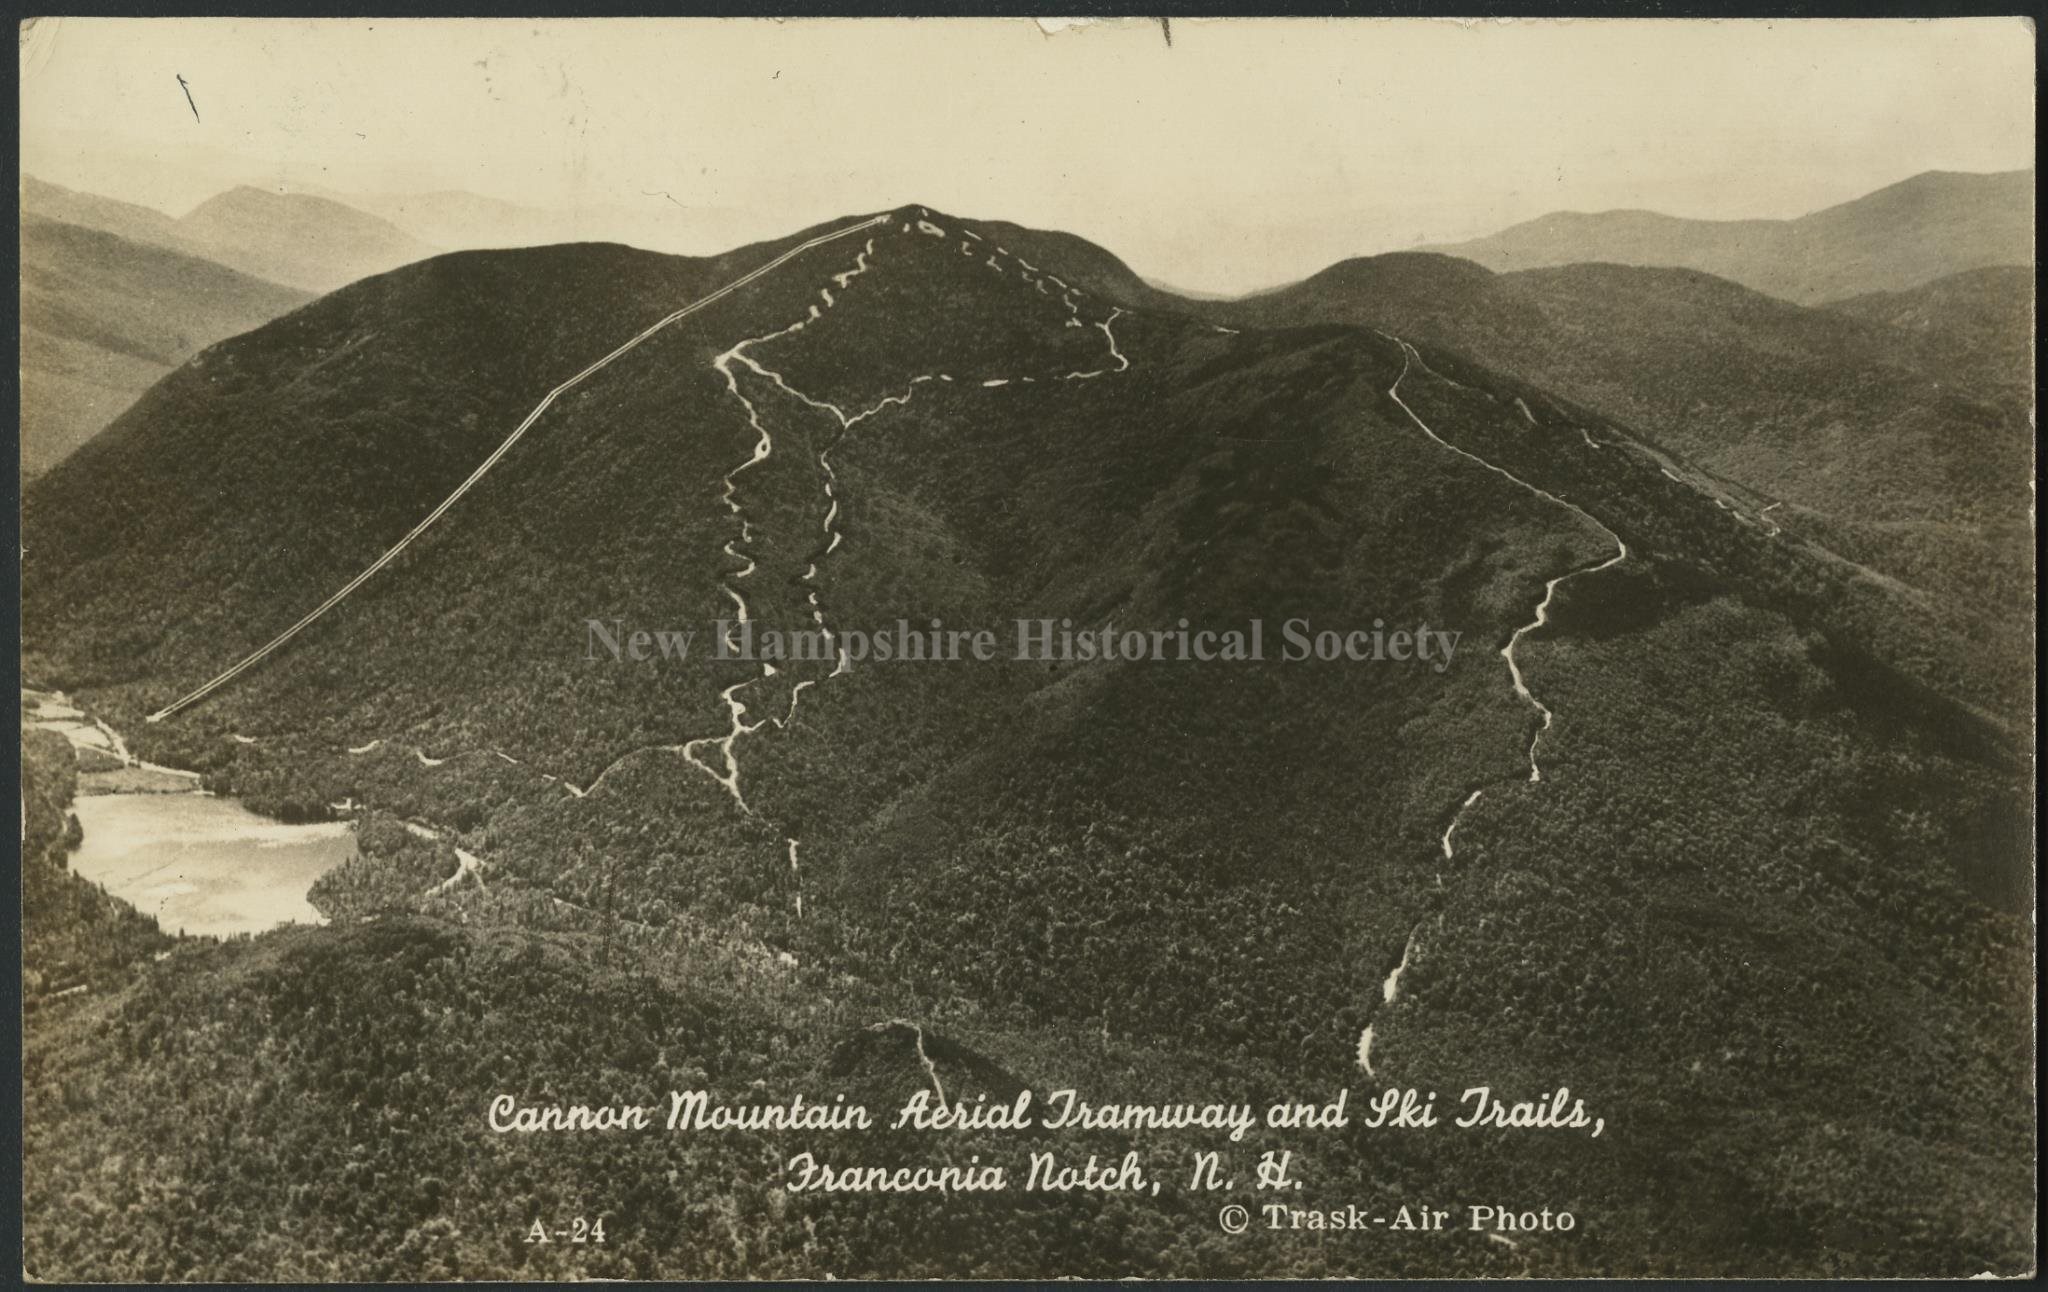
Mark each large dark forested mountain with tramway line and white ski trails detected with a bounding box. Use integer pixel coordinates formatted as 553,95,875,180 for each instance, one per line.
23,207,2032,1278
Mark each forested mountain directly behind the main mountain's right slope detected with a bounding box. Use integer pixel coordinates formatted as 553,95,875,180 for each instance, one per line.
1219,254,2034,638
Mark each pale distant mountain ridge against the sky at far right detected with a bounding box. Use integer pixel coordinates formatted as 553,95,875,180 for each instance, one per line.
1419,170,2034,305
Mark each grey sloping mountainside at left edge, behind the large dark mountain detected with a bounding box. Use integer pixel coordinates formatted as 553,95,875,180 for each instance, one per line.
20,211,311,475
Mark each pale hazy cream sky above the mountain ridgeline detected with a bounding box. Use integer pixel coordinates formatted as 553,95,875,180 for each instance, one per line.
20,18,2034,291
